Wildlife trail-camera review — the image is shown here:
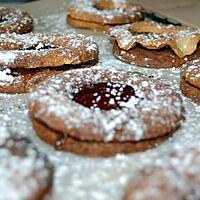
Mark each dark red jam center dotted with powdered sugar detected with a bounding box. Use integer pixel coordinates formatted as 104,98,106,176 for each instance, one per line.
73,82,136,110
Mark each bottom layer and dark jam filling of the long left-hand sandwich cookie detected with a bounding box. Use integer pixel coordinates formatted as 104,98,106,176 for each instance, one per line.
0,60,97,94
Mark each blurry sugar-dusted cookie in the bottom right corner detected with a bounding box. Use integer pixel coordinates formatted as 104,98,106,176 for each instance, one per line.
123,143,200,200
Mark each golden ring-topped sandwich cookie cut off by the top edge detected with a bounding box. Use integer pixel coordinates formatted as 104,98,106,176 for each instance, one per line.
67,0,145,31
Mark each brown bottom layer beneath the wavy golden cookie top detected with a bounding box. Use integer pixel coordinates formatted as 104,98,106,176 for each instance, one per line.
113,42,200,68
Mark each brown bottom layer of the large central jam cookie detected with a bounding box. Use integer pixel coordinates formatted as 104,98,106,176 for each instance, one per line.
32,118,169,157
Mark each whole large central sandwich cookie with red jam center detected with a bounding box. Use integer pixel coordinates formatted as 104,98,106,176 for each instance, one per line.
30,69,183,156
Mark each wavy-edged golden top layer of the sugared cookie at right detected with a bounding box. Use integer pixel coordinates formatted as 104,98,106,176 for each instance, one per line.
109,22,200,58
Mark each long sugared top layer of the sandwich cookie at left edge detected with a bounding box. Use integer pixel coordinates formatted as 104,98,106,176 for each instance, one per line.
0,33,98,69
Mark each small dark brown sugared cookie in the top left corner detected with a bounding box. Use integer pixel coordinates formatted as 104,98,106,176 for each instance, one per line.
0,7,33,34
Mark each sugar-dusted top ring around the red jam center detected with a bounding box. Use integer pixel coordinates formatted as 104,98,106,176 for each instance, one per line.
32,70,182,141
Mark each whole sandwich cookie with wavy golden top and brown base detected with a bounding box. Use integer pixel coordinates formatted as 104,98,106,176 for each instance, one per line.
109,21,200,68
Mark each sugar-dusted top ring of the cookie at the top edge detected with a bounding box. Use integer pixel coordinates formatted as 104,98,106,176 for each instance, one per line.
68,0,142,24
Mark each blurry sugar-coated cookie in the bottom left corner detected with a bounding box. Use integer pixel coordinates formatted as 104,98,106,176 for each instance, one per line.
0,136,53,200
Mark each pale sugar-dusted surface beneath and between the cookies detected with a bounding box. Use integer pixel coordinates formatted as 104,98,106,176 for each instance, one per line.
0,0,200,200
